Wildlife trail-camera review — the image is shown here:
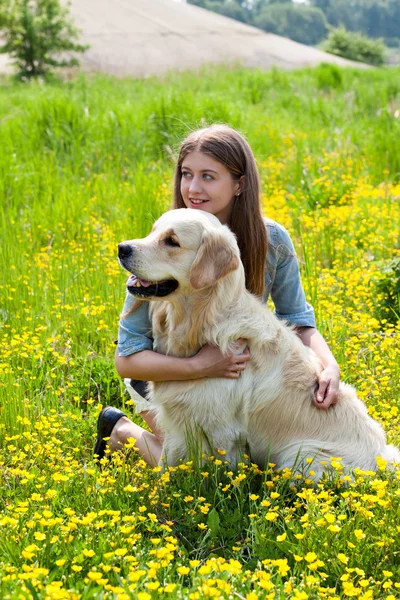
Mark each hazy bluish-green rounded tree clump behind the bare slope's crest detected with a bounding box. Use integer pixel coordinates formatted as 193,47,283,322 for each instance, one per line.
255,3,328,45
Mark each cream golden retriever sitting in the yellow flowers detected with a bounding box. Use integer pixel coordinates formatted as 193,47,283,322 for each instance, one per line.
119,209,400,480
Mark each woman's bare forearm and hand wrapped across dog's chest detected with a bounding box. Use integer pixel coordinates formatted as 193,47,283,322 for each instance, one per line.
115,340,250,381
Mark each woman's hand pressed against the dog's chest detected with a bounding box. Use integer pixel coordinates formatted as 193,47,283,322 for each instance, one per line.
190,339,251,379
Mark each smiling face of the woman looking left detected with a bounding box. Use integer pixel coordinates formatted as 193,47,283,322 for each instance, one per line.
181,151,240,224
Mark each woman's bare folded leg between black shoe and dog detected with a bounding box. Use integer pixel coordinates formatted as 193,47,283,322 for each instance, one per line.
108,411,162,467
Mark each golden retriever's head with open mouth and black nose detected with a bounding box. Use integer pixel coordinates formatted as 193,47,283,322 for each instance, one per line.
118,208,243,300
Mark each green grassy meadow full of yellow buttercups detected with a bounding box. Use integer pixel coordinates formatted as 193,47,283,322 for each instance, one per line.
0,65,400,600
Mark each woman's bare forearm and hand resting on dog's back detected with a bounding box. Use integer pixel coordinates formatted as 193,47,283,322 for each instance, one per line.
296,327,340,408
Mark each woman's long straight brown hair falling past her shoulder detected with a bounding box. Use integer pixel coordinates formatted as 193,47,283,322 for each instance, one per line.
173,125,268,296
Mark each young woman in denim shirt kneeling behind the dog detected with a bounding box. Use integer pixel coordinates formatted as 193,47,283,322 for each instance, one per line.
95,125,340,465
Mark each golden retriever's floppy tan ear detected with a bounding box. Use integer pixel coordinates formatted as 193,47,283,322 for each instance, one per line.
190,232,239,290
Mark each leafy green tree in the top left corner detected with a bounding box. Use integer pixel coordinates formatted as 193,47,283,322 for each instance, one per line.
0,0,87,78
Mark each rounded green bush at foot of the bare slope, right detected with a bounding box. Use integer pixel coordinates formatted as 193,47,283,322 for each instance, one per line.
322,27,386,66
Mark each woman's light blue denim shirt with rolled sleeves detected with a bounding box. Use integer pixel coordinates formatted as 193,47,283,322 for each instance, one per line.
118,219,315,356
